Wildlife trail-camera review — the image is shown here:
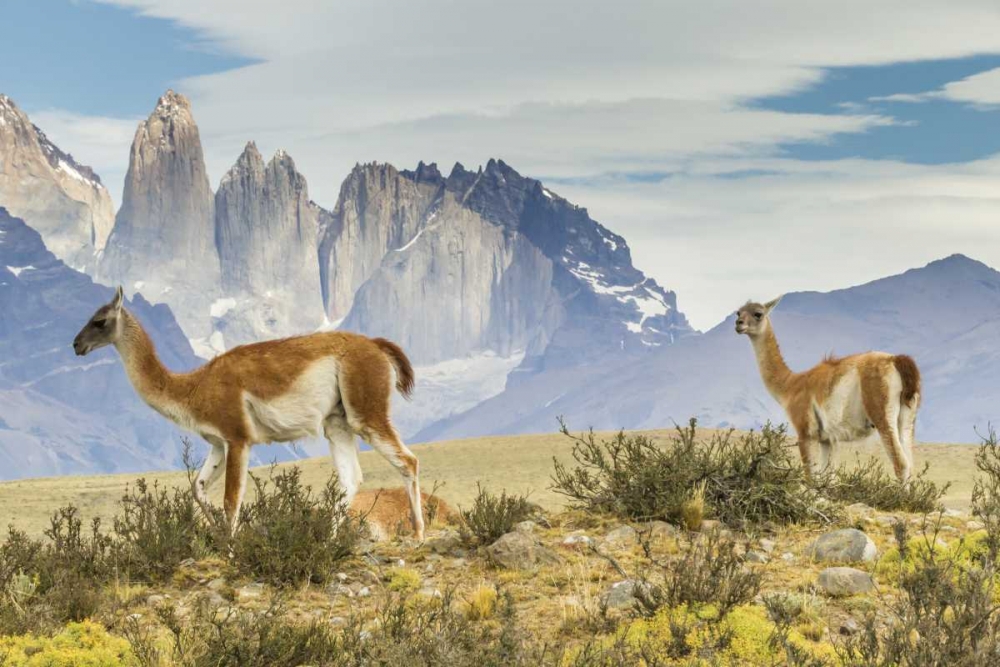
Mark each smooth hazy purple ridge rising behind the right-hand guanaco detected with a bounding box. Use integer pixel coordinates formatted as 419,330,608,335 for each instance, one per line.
416,255,1000,442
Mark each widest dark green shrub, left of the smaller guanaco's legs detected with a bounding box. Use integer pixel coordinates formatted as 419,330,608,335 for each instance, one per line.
553,419,832,527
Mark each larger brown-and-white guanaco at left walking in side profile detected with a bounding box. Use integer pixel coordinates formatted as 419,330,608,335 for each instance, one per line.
73,287,424,540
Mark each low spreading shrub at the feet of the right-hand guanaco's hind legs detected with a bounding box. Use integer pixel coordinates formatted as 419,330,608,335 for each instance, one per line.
817,461,950,514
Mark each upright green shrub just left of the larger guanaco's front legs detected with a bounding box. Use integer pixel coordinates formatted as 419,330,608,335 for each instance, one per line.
114,479,210,580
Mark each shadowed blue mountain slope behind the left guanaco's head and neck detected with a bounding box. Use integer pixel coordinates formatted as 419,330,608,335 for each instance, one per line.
0,208,207,479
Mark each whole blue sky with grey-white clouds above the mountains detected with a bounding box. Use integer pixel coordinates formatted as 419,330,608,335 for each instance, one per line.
0,0,1000,329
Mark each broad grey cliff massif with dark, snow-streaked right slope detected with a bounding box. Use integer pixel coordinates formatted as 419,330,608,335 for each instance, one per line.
320,160,693,368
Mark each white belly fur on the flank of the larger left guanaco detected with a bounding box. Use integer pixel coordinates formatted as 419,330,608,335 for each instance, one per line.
243,357,340,443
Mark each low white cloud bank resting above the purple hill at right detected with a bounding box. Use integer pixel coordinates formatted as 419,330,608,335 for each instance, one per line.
550,156,1000,328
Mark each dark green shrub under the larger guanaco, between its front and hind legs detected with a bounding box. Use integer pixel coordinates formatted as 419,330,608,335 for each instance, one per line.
231,467,360,585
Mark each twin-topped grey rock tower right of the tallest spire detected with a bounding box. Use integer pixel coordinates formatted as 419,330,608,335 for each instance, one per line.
211,142,328,346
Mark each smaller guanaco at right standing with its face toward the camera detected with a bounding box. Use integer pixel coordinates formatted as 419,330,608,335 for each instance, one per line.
736,297,920,483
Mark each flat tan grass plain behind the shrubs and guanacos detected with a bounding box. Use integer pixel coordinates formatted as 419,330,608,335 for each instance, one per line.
0,425,976,535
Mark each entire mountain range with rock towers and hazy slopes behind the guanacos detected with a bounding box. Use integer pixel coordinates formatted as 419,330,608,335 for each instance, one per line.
0,91,1000,478
